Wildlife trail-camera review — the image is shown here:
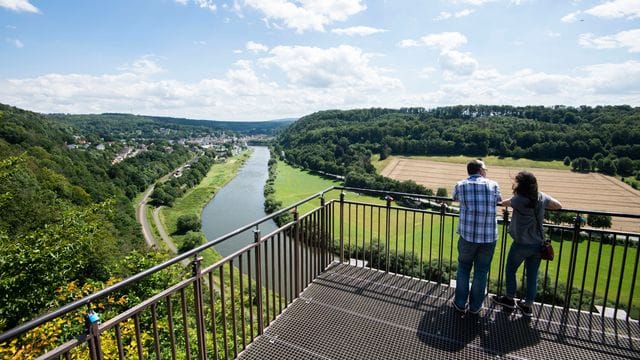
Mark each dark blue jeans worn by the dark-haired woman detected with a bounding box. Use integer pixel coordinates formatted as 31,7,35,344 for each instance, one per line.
505,243,540,305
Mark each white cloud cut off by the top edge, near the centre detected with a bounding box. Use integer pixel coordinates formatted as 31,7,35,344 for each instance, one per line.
245,0,366,33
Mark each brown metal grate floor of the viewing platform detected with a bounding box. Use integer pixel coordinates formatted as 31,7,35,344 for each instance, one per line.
239,263,640,359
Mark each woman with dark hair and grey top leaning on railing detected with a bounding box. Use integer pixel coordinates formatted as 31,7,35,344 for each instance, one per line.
492,171,562,317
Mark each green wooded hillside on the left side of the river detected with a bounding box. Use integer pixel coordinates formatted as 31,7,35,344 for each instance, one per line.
0,104,248,332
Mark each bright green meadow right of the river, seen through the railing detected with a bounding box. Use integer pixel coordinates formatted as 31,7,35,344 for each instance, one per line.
274,158,640,318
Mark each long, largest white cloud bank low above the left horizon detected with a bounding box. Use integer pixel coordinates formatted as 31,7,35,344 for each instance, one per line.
0,46,404,120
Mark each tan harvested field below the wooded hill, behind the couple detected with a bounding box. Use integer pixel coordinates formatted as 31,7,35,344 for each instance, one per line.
381,158,640,232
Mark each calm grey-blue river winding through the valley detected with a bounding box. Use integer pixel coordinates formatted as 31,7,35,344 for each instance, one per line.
202,146,277,256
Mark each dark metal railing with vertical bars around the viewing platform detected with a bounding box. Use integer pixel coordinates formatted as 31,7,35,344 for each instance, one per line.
0,187,640,359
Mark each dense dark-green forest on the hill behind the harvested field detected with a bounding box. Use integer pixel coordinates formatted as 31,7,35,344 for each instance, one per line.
276,105,640,191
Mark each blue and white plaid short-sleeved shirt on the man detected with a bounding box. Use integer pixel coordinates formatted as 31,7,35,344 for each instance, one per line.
453,174,502,243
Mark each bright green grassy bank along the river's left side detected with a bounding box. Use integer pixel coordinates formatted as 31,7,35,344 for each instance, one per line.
158,150,252,265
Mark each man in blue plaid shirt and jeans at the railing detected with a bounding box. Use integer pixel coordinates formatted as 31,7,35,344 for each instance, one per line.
453,160,502,314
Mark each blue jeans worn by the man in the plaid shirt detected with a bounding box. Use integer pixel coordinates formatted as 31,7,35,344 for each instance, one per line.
453,237,496,312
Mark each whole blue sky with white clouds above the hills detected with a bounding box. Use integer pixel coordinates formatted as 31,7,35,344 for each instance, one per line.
0,0,640,120
